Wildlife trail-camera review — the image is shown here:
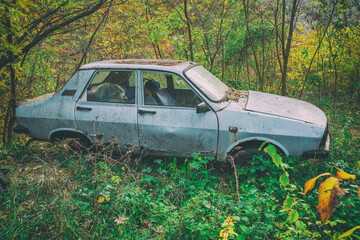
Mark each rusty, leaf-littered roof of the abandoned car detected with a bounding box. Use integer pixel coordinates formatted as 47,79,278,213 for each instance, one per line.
80,59,196,72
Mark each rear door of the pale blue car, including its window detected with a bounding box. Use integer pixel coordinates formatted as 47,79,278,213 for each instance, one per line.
75,70,139,149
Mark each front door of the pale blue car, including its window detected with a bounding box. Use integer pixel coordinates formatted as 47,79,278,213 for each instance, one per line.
138,71,218,156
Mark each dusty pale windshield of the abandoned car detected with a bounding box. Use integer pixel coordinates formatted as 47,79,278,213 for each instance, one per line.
185,65,228,102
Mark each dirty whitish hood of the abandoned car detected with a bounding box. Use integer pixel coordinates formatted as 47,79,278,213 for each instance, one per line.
245,91,327,127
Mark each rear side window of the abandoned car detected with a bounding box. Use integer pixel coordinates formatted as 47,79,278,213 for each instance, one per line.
86,71,136,104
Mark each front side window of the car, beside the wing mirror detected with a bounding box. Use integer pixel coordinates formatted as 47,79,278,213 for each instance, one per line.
143,72,202,108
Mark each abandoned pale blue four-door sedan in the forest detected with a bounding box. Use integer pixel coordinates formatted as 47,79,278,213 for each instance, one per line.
14,60,330,161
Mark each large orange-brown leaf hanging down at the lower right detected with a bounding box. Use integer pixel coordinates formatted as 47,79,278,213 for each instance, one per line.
316,177,345,224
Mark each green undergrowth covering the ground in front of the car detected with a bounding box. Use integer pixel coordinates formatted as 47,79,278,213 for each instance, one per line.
0,99,360,239
